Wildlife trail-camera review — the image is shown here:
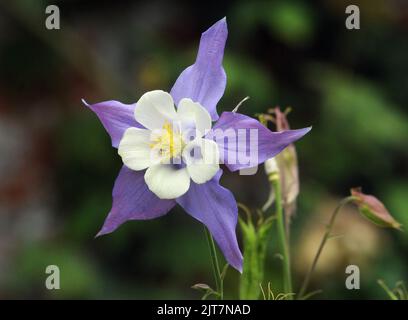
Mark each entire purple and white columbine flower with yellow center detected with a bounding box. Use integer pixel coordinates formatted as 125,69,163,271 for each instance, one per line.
84,18,310,271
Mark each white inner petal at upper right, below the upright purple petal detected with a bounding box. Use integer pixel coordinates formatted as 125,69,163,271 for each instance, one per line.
177,98,211,137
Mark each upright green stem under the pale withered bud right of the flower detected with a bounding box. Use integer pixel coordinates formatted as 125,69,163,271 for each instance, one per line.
271,176,293,294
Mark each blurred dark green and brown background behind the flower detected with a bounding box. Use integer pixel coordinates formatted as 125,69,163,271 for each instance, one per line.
0,0,408,299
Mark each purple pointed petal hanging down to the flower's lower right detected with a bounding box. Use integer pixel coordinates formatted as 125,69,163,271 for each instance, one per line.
177,170,243,272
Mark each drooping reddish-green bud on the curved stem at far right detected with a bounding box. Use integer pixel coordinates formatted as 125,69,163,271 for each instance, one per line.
351,188,401,230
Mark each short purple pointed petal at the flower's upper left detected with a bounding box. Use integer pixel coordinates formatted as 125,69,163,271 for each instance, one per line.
82,100,142,148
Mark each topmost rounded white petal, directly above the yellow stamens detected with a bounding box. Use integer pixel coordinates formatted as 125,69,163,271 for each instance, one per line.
135,90,177,130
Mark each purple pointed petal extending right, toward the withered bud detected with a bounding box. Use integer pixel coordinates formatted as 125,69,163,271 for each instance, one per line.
206,112,311,171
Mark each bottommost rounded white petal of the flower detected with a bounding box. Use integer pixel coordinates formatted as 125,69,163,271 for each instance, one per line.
145,164,190,199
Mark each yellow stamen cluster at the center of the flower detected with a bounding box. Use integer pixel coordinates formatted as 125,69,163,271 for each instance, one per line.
150,121,186,160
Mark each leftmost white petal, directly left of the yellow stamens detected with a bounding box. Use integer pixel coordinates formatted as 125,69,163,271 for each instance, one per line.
118,128,160,171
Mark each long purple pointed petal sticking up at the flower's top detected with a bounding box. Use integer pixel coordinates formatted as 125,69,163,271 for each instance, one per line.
170,18,228,120
